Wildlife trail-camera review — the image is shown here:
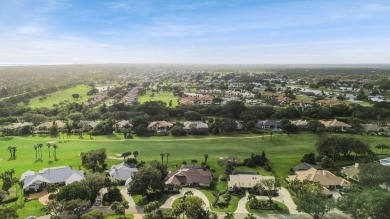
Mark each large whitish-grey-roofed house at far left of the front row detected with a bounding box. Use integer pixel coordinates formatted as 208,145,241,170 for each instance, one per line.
20,166,85,191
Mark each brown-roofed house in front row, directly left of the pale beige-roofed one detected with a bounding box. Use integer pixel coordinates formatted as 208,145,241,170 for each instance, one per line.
165,168,213,191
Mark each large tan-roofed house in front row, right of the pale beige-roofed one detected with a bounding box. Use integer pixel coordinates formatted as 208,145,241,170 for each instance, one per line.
287,168,349,190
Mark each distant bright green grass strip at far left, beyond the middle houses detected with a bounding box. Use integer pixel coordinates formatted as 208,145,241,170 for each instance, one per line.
24,85,91,108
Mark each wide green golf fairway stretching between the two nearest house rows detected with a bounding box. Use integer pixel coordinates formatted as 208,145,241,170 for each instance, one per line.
0,134,388,179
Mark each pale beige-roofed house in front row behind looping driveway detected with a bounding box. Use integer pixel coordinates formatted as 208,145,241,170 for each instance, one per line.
228,174,275,191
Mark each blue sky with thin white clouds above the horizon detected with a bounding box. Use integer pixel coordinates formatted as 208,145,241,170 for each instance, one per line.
0,0,390,65
